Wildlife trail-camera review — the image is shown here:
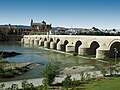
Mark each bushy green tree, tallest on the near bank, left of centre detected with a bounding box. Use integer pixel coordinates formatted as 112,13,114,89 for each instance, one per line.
43,60,60,85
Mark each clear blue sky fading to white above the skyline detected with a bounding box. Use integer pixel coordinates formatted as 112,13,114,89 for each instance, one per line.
0,0,120,29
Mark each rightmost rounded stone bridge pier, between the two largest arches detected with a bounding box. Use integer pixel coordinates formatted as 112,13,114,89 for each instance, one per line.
96,48,109,59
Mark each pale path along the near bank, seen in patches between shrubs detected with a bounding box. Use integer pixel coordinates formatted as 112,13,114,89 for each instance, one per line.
0,69,102,89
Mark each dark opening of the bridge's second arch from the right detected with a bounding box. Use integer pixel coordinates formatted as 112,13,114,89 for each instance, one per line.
89,41,100,55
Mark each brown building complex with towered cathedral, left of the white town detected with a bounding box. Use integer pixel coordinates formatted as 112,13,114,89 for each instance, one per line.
0,20,52,35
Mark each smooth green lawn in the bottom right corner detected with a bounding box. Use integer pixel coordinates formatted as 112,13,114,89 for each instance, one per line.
86,77,120,90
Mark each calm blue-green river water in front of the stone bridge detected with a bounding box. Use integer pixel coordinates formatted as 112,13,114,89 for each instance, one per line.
0,42,109,81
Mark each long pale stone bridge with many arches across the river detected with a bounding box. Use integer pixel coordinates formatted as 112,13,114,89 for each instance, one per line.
21,35,120,59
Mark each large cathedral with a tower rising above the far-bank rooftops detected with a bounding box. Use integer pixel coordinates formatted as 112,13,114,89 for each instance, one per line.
30,19,52,34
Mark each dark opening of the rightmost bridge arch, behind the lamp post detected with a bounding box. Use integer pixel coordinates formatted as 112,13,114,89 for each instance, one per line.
109,42,120,57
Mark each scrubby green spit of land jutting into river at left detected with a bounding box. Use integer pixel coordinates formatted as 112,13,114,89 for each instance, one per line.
0,60,38,79
